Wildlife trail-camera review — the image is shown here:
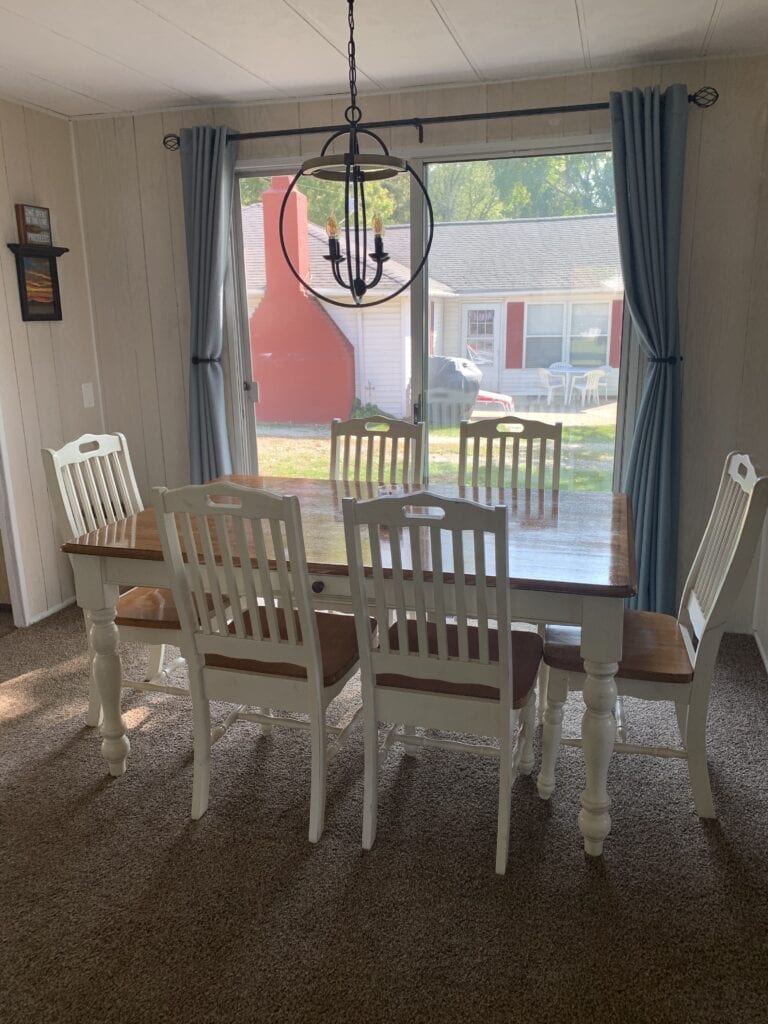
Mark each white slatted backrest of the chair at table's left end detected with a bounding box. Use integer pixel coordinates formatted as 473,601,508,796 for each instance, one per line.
42,434,143,542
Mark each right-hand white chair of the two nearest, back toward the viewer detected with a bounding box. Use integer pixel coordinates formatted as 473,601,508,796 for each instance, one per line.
343,493,542,874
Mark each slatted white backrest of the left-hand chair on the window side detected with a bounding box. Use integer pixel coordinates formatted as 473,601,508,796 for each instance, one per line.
331,416,424,483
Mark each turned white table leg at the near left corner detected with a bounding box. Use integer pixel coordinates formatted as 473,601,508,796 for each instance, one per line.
88,591,131,775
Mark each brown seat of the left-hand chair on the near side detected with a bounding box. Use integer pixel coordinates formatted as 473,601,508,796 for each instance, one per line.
205,608,376,686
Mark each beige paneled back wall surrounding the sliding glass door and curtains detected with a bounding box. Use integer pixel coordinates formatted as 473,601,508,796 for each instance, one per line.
75,57,768,629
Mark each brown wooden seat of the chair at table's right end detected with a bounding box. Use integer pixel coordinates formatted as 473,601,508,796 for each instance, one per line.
544,609,693,683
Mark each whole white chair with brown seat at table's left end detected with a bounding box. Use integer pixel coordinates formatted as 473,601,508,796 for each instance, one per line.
42,434,188,725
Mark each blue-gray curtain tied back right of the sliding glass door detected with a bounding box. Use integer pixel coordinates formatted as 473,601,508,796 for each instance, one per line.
610,85,688,612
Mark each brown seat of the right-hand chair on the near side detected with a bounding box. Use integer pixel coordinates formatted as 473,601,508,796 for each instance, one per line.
376,618,542,709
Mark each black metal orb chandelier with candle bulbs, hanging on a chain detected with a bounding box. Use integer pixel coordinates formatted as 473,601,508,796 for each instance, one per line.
280,0,434,307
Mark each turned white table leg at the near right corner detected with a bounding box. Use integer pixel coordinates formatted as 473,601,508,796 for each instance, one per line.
579,599,624,857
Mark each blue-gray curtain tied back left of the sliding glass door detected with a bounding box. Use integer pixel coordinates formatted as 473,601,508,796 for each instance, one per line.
181,127,237,483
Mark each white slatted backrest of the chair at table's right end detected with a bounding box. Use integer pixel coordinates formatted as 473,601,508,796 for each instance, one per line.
678,452,768,666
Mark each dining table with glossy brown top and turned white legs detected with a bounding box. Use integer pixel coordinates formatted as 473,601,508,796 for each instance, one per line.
62,475,636,856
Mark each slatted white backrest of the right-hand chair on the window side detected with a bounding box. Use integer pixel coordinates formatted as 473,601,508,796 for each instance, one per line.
459,416,562,490
